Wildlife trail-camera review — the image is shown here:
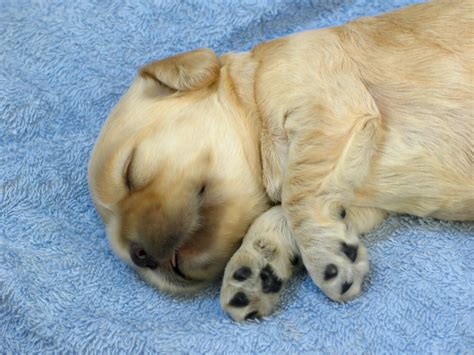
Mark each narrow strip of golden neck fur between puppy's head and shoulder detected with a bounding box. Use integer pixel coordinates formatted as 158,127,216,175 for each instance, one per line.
219,52,263,193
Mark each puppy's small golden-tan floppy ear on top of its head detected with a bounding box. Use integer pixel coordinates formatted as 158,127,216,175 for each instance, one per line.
140,48,221,91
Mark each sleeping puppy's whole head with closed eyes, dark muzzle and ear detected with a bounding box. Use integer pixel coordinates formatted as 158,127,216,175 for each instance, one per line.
89,49,267,292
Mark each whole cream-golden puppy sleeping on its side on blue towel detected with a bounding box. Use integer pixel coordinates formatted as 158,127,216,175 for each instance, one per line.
89,0,474,320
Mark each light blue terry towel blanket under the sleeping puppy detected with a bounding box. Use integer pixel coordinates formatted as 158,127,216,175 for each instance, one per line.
0,0,474,354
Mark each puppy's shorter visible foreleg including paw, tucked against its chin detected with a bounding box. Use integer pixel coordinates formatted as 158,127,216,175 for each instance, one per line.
220,206,300,321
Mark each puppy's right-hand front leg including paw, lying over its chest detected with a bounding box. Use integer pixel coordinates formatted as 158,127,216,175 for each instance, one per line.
282,84,385,301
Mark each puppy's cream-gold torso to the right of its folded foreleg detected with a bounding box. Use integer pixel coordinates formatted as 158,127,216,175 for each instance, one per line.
337,1,474,219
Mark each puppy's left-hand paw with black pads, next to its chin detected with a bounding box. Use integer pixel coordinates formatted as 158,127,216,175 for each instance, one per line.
220,240,292,321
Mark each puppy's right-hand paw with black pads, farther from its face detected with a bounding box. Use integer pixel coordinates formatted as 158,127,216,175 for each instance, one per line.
302,239,369,302
